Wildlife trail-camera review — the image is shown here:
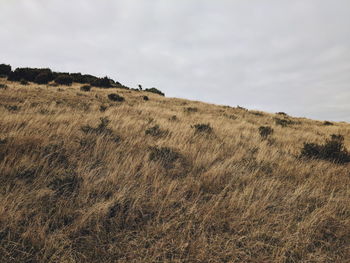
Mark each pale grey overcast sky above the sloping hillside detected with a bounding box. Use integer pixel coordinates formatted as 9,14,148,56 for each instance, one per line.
0,0,350,122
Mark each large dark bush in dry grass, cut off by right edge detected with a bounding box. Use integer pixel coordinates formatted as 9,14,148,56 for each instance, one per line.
301,134,350,164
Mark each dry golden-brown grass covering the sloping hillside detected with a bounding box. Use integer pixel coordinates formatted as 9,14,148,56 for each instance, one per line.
0,79,350,263
